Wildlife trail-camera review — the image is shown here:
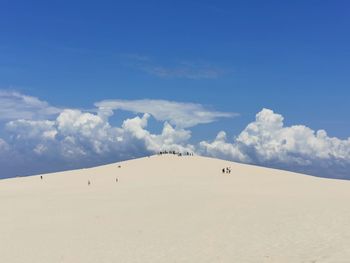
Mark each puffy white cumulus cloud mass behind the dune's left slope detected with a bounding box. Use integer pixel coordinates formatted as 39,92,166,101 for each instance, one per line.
0,109,193,177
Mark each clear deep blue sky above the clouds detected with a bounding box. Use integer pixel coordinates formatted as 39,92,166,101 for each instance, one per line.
0,0,350,179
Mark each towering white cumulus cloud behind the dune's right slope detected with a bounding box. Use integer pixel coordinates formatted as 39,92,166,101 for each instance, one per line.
200,109,350,178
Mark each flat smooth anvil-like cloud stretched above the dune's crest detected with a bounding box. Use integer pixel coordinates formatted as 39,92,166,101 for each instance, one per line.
95,99,238,128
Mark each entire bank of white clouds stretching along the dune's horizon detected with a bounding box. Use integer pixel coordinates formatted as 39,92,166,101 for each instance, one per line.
0,93,350,179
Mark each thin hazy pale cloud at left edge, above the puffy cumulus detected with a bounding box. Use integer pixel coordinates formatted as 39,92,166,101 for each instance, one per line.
0,90,61,121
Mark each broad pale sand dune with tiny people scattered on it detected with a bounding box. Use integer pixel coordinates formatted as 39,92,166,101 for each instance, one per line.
0,156,350,263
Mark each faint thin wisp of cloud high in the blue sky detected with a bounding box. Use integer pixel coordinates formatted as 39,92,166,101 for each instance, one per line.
123,54,233,79
